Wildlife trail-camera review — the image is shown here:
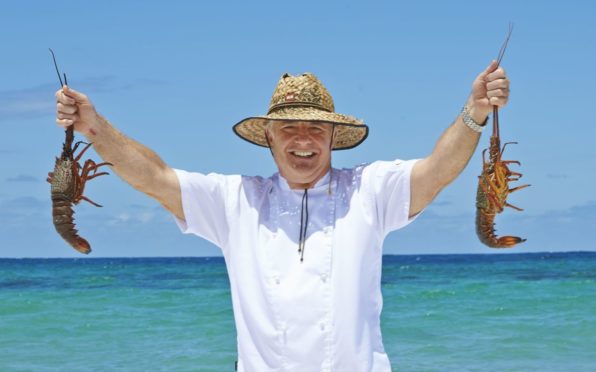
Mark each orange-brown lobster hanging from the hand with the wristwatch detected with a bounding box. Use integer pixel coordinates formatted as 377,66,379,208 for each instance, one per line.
476,26,530,248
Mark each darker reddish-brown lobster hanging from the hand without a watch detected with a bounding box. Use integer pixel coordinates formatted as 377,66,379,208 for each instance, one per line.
47,49,112,254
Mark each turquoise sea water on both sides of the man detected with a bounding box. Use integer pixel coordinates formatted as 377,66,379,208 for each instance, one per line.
0,253,596,371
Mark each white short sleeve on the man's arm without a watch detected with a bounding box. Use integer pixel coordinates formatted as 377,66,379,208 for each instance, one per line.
174,169,229,248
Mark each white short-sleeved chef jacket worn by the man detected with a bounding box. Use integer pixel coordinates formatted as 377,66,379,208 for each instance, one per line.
176,160,416,372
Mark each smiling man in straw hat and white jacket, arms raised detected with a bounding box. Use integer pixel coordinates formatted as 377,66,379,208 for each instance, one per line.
56,61,509,371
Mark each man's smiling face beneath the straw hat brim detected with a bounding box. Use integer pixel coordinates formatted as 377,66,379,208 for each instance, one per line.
266,121,333,189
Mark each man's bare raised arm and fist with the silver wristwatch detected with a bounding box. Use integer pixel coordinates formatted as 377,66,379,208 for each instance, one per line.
410,61,509,216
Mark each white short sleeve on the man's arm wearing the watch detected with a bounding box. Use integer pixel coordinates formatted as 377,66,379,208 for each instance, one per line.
362,159,418,235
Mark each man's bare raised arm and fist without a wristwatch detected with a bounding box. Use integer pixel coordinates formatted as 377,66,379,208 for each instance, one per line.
56,86,184,219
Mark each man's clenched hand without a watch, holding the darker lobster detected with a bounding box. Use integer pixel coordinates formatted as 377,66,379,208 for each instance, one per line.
56,85,99,138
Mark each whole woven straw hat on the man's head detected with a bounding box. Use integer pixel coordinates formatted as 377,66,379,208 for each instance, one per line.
233,73,368,150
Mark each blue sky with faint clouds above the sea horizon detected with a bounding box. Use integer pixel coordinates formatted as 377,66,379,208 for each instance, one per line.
0,0,596,257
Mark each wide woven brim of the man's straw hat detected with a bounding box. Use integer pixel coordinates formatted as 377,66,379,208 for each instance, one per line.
233,107,368,150
